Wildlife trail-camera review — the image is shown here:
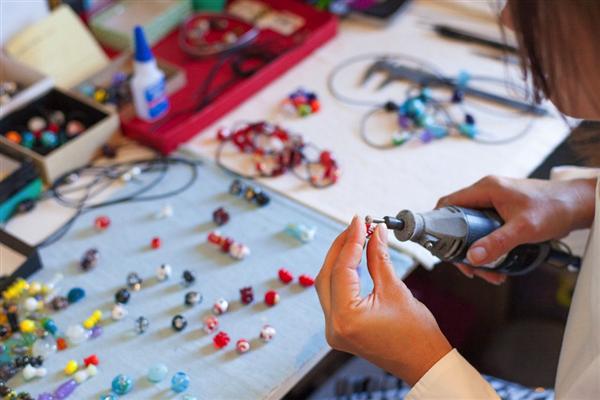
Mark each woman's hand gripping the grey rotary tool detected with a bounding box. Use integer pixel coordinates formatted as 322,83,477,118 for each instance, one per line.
437,176,596,284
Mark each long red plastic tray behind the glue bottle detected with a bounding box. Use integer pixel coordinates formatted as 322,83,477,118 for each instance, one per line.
121,0,337,154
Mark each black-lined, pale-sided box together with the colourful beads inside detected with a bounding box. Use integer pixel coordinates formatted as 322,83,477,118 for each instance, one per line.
0,88,119,184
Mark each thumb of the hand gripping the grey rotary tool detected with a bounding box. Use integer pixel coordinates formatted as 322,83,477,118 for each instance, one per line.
467,221,525,266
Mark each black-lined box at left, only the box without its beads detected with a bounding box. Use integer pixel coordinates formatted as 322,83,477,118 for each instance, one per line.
0,89,119,183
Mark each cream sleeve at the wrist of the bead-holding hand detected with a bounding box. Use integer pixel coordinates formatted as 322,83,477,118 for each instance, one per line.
405,349,500,400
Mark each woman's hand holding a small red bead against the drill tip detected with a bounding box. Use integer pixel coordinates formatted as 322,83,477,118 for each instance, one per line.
316,217,452,385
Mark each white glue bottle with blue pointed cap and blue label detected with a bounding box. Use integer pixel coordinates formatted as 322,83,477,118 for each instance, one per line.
130,26,169,121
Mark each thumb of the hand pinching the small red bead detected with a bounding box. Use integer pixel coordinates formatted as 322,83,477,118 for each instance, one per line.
367,224,397,291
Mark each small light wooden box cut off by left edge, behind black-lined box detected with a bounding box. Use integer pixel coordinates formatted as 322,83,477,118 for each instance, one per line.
0,53,53,118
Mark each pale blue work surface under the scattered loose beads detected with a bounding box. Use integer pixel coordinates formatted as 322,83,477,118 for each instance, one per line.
16,164,412,400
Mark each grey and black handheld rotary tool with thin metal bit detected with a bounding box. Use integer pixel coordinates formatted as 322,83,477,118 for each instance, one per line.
367,206,581,275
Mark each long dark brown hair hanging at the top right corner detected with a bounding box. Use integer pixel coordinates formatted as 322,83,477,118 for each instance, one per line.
506,0,600,113
